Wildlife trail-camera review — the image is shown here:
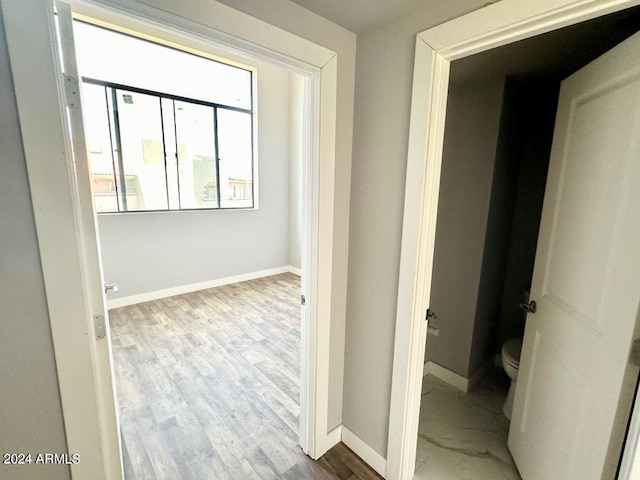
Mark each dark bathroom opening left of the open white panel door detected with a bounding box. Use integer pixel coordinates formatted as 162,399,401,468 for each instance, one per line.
416,11,638,478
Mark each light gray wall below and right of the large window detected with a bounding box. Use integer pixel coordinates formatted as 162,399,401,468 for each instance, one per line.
98,65,300,298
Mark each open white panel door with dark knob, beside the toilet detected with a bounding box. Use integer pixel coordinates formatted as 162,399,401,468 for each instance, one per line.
509,30,640,480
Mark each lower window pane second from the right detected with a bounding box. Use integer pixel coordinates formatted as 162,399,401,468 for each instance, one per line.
175,101,219,208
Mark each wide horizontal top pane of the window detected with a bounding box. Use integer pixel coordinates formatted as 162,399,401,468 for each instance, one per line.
74,21,252,110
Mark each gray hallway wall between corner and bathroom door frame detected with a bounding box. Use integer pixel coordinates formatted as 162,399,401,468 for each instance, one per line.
343,0,485,456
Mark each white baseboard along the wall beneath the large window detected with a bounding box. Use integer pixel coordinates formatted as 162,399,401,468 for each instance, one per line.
107,266,300,308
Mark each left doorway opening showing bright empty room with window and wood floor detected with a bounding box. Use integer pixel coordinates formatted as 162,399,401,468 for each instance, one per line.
69,15,308,478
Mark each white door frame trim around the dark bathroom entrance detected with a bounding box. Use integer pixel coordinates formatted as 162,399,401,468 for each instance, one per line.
386,0,640,480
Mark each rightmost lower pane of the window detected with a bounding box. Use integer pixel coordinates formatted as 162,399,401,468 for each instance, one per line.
217,108,253,208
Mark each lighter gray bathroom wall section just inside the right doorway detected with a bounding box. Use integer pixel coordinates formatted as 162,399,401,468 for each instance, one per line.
426,79,504,377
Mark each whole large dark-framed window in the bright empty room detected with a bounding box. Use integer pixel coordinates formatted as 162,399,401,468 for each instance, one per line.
75,22,254,212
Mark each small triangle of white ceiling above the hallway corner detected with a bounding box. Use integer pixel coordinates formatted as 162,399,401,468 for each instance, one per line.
292,0,430,33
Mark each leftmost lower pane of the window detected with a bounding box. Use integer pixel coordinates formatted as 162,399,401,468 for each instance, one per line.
82,84,118,212
